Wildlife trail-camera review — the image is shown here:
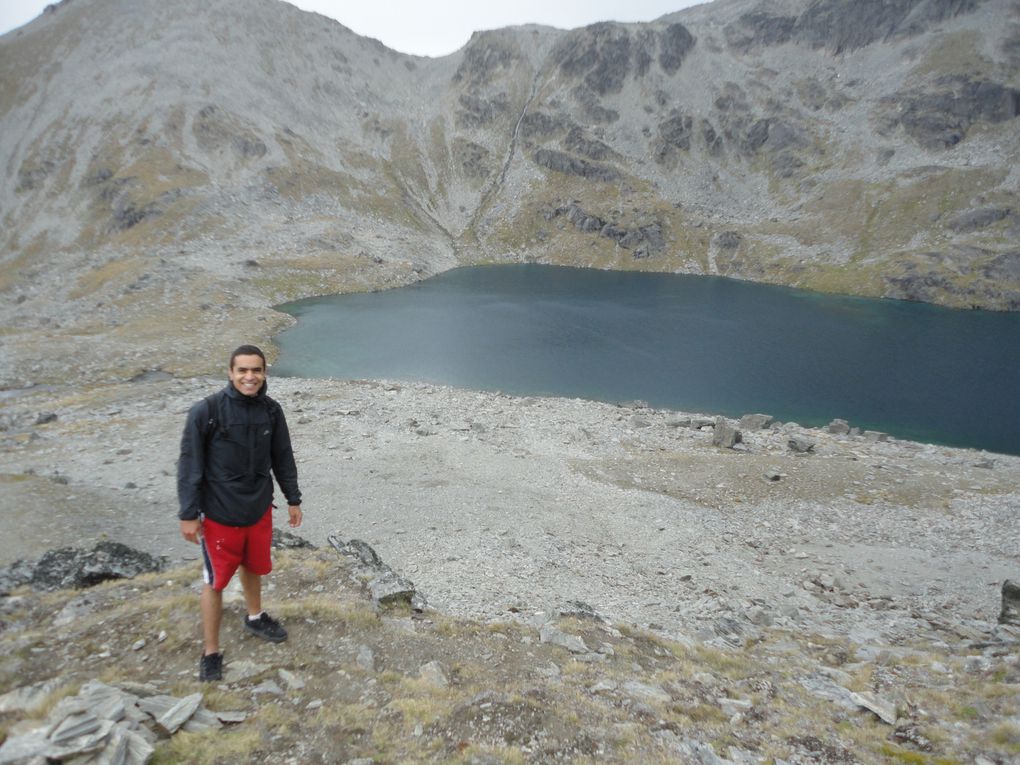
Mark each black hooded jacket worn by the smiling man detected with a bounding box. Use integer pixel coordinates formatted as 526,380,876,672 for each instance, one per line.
177,384,301,526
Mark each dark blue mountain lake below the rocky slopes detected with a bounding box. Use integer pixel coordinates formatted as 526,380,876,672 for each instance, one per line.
273,265,1020,454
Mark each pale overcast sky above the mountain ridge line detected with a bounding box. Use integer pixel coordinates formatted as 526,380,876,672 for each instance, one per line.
0,0,701,56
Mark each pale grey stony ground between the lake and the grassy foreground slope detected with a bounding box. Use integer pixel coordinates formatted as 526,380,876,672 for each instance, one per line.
0,374,1020,647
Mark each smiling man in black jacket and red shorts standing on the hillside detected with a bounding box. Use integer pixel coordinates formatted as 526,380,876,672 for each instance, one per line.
177,346,301,680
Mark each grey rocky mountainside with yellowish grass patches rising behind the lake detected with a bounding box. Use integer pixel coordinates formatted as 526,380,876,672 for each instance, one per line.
0,0,1020,385
